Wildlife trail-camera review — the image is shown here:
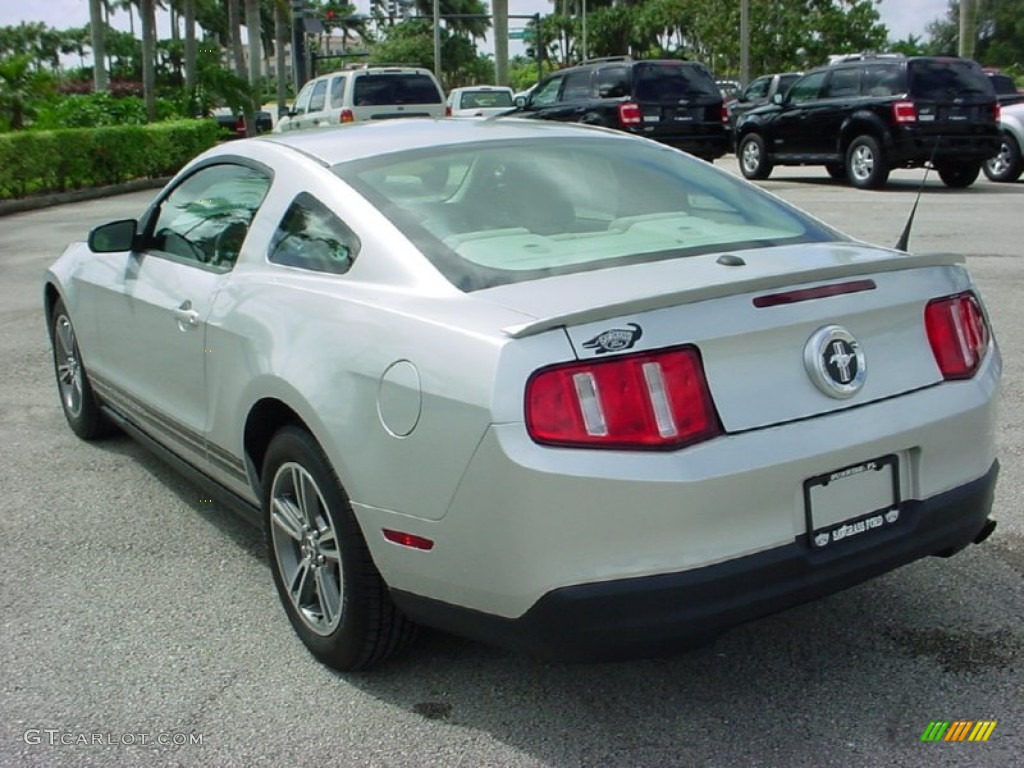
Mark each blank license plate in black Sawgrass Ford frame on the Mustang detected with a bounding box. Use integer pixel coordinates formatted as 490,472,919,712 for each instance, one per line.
804,455,900,549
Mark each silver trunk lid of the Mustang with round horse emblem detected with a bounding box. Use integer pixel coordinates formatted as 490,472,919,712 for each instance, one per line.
481,243,971,432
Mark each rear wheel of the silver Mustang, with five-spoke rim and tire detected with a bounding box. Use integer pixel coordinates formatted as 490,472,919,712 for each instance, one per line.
262,426,416,672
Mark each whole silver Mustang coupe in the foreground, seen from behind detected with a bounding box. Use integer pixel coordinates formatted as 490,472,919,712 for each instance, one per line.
45,119,1001,670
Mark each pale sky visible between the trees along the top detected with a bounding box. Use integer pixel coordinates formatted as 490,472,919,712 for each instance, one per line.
0,0,948,54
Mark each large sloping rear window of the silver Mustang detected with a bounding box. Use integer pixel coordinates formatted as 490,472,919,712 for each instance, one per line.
334,136,843,291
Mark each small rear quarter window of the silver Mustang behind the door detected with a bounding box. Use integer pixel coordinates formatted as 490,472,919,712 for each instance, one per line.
267,193,359,274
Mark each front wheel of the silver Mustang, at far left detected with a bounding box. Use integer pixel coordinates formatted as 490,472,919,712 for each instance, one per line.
50,299,111,440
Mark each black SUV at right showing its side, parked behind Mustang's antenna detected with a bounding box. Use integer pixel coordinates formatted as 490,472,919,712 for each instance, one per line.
736,54,999,188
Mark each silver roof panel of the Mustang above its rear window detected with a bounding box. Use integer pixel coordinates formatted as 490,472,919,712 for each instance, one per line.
251,118,626,166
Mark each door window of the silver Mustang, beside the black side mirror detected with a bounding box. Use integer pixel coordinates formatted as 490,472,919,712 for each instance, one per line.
147,163,270,271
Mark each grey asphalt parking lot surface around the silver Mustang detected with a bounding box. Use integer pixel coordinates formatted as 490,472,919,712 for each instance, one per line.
0,157,1024,768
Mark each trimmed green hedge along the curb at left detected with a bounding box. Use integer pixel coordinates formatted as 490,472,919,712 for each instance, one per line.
0,120,220,200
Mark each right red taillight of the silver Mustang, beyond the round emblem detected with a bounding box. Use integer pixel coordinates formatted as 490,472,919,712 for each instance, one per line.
925,293,988,379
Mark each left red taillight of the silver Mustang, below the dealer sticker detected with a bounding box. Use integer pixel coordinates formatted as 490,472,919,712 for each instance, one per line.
525,346,722,450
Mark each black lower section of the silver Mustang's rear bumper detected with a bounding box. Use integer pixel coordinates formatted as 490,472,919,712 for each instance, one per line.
392,462,998,660
